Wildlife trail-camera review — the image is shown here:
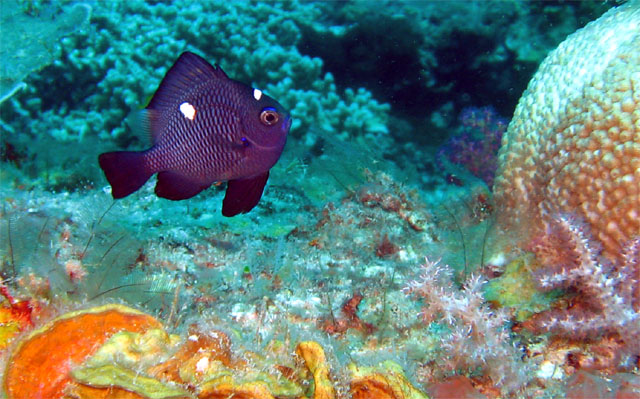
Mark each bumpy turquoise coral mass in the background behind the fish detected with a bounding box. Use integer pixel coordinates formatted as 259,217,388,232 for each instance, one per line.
5,0,389,144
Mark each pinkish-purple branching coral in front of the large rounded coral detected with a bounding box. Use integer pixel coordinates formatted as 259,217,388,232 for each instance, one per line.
526,215,640,355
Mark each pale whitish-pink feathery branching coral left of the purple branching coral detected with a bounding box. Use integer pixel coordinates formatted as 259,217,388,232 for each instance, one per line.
404,259,527,390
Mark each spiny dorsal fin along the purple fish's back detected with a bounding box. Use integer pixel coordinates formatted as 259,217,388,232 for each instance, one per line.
142,51,229,142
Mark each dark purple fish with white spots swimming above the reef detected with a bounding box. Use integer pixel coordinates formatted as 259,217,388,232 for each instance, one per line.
98,52,291,216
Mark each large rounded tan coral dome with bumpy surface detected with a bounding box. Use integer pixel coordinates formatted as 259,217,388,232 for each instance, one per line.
494,1,640,260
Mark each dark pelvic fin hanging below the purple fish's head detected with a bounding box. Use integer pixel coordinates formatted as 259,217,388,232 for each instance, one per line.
222,171,269,217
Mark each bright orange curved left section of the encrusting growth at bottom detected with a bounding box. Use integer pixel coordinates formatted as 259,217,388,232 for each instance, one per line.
3,305,161,399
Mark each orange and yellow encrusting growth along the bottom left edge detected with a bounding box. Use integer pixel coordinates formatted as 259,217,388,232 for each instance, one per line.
3,305,440,399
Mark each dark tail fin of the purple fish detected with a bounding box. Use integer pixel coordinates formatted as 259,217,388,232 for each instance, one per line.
98,151,153,199
